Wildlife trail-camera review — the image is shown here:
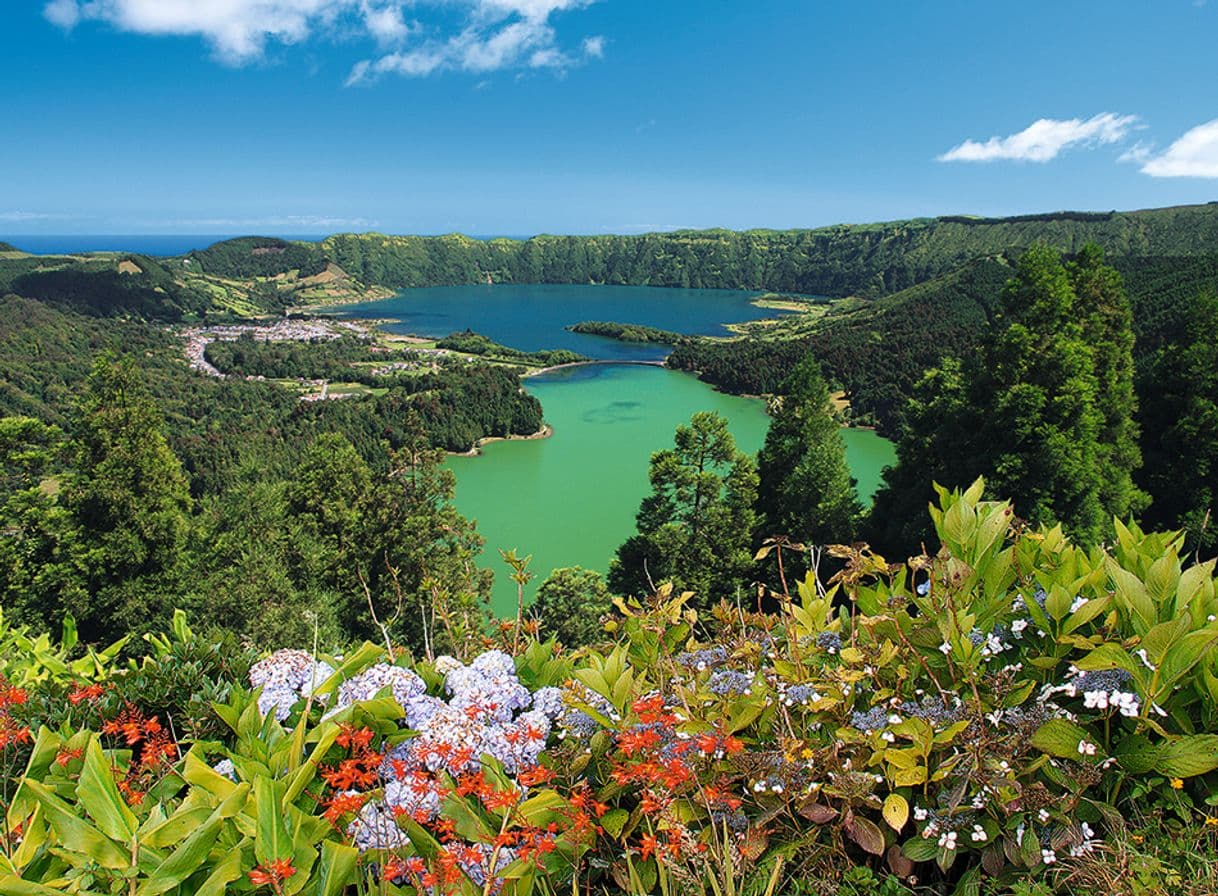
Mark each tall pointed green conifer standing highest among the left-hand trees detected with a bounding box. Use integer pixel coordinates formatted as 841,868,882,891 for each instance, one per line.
63,355,191,638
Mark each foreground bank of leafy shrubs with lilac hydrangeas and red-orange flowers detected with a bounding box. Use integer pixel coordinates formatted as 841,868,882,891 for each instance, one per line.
0,485,1218,896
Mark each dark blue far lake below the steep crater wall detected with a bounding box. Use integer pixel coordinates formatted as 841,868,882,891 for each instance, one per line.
331,284,780,360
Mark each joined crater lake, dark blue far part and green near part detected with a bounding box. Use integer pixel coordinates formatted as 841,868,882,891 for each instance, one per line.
331,284,895,615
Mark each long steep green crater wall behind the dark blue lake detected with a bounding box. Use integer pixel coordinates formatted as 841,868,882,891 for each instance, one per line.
299,205,1218,298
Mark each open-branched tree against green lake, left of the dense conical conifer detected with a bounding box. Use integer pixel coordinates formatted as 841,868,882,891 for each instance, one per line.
609,411,758,603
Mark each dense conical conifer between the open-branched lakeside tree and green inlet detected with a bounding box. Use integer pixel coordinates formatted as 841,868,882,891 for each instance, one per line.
758,354,862,544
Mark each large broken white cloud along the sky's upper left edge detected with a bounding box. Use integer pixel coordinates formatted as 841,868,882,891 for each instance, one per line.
43,0,604,76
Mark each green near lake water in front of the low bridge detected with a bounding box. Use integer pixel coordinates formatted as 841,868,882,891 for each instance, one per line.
447,365,894,614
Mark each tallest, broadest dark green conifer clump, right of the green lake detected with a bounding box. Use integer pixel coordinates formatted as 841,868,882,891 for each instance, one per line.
871,246,1140,549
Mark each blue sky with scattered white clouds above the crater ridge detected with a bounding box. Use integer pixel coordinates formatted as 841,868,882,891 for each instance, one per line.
0,0,1218,236
